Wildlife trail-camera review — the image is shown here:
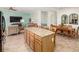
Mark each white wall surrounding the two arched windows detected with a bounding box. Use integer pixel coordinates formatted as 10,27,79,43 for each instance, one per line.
57,7,79,26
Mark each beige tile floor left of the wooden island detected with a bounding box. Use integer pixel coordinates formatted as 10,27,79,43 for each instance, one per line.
4,34,32,52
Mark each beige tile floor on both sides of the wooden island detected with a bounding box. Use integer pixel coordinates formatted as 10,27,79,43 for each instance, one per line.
4,34,79,52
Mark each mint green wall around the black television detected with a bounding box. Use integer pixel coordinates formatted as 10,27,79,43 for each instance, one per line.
0,8,31,34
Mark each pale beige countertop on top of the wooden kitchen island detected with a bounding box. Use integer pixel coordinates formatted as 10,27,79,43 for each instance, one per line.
25,27,55,37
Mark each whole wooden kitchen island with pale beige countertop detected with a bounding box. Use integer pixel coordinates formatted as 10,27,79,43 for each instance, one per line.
24,27,55,52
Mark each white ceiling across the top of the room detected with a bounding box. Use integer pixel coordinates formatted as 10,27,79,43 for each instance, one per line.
6,7,60,13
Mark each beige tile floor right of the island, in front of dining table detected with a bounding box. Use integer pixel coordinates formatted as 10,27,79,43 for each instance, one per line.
55,35,79,52
